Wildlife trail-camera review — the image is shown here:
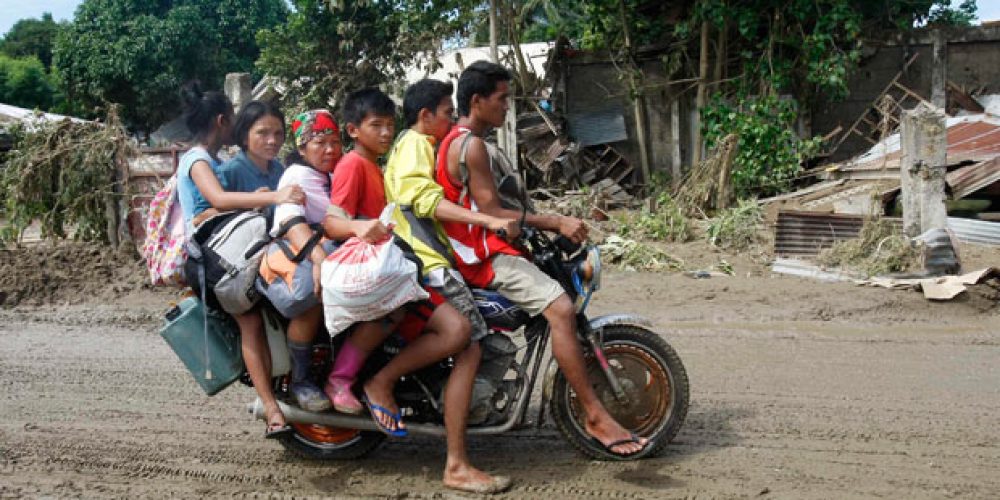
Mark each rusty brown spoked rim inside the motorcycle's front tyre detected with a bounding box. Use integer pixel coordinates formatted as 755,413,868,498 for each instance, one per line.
566,342,674,436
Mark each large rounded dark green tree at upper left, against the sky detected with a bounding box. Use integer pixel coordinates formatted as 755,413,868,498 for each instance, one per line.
53,0,287,132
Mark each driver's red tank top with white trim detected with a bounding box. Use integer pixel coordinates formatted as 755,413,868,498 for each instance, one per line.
434,126,521,288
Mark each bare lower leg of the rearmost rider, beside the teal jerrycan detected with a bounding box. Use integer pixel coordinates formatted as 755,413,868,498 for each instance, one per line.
235,309,285,430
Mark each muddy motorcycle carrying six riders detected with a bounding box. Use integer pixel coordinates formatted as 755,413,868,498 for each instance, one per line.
248,223,689,460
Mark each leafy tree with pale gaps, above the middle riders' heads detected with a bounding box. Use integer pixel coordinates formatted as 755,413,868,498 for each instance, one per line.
257,0,478,107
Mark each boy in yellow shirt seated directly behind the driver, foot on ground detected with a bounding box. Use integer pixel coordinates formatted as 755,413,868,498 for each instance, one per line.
385,79,518,493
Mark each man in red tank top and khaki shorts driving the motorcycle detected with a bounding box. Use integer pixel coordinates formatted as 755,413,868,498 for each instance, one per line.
435,61,648,456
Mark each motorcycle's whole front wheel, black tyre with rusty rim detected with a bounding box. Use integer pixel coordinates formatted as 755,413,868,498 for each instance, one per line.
549,325,689,460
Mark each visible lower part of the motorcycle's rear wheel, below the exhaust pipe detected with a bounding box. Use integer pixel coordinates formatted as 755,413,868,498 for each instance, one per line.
278,423,385,460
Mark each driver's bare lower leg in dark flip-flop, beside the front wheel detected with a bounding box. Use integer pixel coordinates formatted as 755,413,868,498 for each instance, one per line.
542,295,648,455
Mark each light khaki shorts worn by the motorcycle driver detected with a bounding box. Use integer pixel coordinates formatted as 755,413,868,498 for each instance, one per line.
489,254,566,316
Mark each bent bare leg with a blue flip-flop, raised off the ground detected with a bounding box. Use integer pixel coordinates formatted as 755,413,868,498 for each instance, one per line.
364,303,471,430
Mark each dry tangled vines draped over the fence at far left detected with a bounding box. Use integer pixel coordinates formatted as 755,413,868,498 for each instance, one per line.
0,108,133,243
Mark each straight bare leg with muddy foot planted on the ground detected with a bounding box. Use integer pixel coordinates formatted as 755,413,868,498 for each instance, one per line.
444,342,510,493
